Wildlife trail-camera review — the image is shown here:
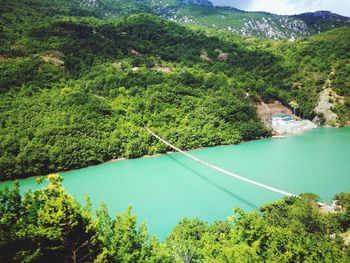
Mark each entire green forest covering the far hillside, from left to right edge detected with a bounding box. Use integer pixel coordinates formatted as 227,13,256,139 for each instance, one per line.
0,0,350,180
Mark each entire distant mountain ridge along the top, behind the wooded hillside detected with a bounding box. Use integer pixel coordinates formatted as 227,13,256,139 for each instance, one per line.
77,0,350,39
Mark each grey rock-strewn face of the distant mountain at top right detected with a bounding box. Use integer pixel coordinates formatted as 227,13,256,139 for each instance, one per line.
157,3,350,40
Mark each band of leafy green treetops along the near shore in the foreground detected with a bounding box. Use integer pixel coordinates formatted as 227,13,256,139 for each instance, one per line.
0,175,350,262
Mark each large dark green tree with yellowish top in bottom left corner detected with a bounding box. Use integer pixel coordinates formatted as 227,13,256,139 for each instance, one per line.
0,175,98,262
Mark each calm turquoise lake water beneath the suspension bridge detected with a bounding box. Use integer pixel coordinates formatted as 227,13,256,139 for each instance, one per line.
0,128,350,239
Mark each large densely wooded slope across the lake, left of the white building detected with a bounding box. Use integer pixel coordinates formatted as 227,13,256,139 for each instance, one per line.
0,3,268,180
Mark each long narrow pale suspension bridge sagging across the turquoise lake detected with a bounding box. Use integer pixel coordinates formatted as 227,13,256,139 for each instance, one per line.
146,127,332,211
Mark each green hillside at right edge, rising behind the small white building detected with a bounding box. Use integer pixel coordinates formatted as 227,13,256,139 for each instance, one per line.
270,28,350,125
